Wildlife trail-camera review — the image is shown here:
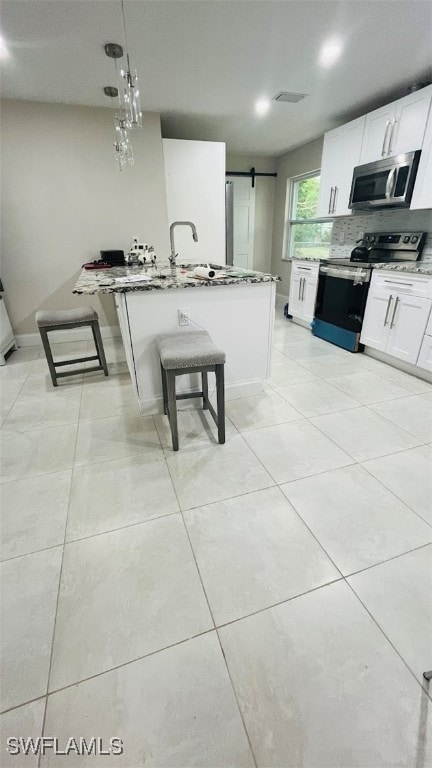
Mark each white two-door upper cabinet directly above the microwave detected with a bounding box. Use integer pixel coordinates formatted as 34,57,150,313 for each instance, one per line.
360,85,432,165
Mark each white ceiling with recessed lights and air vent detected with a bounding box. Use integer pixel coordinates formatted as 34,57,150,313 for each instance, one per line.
0,0,432,155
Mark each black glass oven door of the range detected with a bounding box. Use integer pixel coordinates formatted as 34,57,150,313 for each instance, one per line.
315,264,371,333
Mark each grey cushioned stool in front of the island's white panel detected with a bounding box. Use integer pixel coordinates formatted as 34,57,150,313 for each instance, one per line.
157,331,225,451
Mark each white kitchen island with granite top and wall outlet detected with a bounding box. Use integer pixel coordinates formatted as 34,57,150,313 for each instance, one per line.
73,265,280,415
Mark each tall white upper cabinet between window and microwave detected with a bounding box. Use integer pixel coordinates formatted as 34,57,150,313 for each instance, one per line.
318,117,366,216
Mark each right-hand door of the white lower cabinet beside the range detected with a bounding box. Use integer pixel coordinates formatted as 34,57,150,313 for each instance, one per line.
386,294,431,364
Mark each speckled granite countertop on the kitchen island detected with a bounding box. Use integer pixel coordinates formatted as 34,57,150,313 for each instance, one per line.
73,264,281,295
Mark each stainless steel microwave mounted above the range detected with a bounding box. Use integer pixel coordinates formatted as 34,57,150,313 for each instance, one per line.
349,150,421,210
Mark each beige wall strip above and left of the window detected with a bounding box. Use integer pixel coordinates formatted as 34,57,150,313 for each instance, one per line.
271,138,323,296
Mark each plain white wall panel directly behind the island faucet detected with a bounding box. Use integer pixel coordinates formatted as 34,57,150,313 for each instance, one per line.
162,139,226,264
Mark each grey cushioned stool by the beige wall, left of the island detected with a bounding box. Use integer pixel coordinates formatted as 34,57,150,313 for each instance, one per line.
35,307,108,387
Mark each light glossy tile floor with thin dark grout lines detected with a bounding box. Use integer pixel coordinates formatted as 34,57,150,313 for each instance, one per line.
0,316,432,768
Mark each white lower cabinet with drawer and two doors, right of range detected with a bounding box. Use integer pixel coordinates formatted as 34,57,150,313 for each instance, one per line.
360,271,432,365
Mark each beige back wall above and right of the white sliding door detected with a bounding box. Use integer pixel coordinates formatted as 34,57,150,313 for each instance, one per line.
226,153,276,272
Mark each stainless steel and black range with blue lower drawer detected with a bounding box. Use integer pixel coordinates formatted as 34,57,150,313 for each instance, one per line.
312,232,426,352
